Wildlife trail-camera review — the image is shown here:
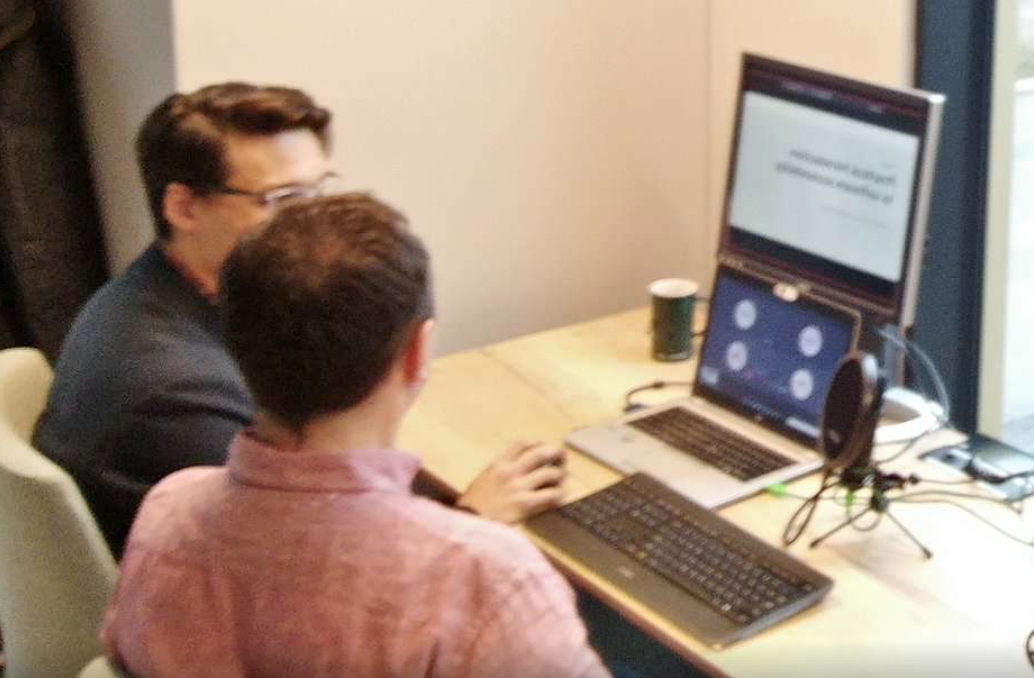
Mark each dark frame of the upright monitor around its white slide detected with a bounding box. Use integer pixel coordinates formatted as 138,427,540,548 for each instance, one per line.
719,53,944,328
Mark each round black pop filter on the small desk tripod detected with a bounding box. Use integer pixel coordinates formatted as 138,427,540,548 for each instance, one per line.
819,351,884,482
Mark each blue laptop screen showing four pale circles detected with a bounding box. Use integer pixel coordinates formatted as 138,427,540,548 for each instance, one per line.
694,267,858,443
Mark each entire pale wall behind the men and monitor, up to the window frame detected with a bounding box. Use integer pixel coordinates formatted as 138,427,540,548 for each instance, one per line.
70,0,913,352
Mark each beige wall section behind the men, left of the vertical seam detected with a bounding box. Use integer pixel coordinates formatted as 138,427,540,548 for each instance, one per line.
175,0,707,352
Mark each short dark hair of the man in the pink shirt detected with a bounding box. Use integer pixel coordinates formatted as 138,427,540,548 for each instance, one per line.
219,193,433,430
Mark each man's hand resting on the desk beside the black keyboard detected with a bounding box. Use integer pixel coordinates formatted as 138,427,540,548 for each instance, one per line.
456,442,567,524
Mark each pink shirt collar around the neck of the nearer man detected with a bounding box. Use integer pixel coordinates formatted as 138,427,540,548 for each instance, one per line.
226,431,420,493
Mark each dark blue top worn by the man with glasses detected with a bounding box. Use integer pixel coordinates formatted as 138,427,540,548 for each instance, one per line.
33,245,253,557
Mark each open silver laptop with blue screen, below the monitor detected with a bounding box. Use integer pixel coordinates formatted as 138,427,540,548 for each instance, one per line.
566,259,861,509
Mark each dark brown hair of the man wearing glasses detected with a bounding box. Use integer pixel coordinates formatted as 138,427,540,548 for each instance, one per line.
136,83,331,238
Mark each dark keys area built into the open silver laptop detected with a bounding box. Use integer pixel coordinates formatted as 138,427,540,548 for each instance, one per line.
628,407,794,481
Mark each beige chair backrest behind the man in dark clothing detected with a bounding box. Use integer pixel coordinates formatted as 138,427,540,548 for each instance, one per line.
0,348,118,678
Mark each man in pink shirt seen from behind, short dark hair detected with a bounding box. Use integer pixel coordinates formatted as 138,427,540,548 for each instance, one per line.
102,194,608,678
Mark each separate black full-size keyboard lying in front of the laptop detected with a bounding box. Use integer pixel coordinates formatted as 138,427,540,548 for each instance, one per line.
526,473,832,647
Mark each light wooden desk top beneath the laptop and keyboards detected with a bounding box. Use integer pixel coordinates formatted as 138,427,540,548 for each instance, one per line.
400,309,1034,678
